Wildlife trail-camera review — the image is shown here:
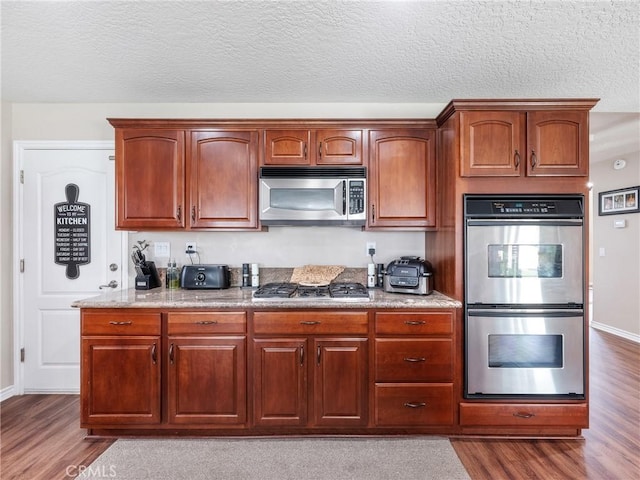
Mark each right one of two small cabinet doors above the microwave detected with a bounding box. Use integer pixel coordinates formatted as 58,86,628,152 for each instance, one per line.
316,130,362,165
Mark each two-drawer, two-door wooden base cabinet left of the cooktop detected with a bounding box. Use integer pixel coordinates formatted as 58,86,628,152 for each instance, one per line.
80,309,247,429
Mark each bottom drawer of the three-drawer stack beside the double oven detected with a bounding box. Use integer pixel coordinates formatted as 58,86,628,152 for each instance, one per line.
375,383,453,427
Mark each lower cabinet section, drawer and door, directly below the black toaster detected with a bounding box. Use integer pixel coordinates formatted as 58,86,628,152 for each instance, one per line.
166,312,247,426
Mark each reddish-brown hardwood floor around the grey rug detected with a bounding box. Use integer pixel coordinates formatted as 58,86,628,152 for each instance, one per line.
0,329,640,480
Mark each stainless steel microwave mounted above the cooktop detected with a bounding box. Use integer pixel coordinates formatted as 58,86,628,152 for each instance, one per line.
259,167,367,226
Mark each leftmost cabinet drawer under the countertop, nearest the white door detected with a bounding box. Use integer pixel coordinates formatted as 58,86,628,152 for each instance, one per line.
81,311,160,335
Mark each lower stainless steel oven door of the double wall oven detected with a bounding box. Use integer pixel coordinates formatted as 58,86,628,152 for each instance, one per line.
465,309,585,399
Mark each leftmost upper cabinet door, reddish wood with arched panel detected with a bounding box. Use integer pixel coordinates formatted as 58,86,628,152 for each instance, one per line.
115,129,185,229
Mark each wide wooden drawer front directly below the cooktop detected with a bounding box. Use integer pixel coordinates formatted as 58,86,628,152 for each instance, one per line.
253,311,369,335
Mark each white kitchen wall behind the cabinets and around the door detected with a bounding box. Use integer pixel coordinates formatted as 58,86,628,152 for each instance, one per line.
0,103,445,390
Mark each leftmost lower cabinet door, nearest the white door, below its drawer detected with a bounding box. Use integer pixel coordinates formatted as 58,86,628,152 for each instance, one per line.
80,336,160,428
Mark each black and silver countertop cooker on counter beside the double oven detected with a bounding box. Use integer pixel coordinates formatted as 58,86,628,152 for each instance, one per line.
384,257,433,295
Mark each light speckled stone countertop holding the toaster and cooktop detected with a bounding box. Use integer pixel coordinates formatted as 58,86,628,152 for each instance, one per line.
71,287,462,309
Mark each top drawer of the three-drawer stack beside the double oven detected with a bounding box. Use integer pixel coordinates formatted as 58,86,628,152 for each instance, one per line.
376,312,453,335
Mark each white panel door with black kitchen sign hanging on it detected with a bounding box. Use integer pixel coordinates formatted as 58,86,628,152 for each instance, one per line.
15,142,127,393
